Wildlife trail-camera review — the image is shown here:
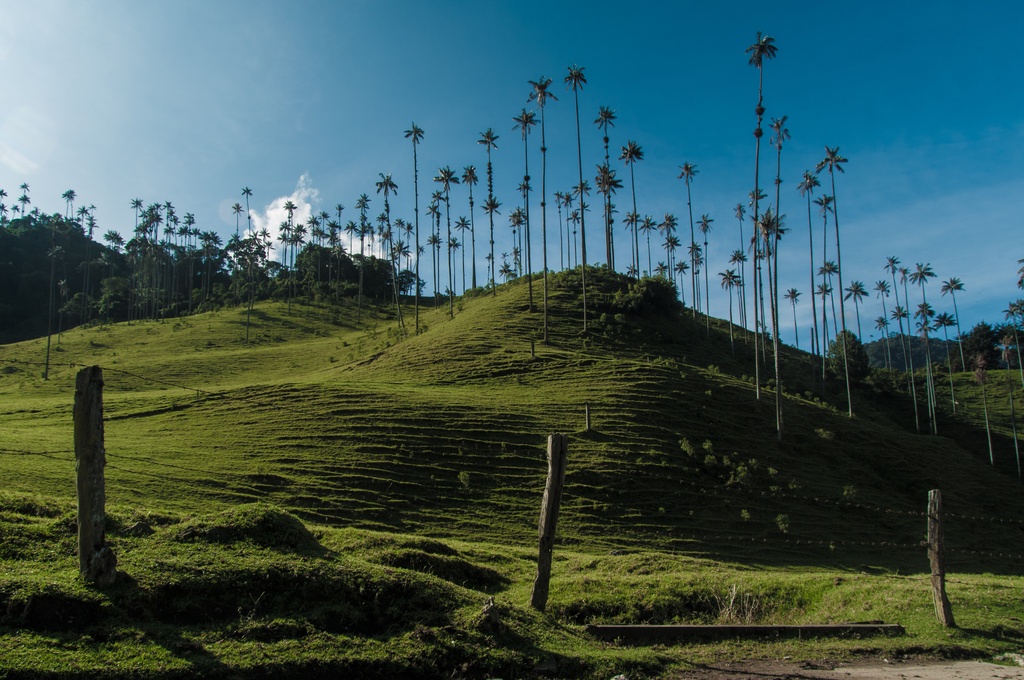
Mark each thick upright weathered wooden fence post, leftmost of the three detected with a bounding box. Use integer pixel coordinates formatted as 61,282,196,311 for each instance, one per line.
75,366,118,587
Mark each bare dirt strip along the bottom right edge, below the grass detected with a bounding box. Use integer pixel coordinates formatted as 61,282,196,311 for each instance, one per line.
673,660,1024,680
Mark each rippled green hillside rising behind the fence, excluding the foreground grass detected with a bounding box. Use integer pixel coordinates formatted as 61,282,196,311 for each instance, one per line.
0,274,1024,571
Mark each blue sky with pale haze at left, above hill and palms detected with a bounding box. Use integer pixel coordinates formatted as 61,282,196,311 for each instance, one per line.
0,0,1024,348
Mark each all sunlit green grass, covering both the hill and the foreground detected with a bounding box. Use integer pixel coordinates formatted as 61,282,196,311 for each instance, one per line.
6,273,1024,677
